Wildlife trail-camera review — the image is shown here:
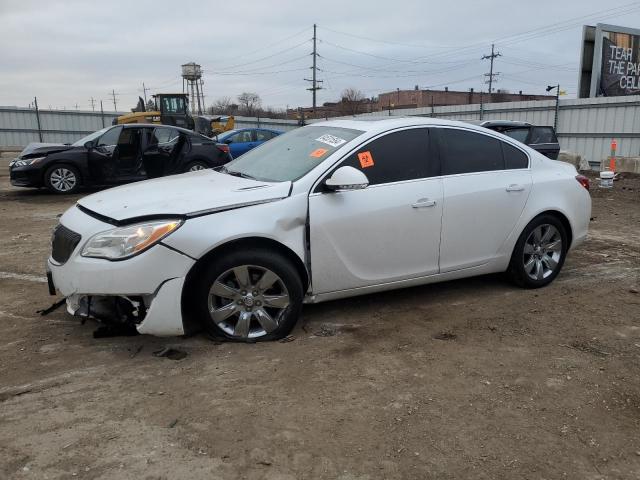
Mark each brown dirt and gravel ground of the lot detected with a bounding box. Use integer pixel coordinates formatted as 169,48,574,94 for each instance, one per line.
0,175,640,480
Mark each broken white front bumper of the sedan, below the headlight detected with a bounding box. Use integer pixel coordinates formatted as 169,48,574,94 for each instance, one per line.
47,204,195,336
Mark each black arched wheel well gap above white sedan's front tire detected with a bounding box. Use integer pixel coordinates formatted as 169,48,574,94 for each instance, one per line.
182,237,310,331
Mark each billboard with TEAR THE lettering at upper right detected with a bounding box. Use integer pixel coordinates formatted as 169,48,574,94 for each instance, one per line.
579,24,640,97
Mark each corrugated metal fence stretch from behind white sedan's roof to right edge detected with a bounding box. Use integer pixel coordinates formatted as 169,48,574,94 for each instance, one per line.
342,95,640,166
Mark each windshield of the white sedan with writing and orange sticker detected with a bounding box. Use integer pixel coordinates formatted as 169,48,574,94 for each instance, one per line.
224,126,364,182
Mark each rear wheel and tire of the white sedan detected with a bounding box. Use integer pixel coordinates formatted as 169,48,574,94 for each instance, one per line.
507,214,569,288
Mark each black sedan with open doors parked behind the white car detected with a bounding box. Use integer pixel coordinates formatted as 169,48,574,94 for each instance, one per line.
9,124,231,193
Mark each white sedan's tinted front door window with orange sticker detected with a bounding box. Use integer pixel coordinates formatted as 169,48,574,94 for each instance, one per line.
340,128,437,185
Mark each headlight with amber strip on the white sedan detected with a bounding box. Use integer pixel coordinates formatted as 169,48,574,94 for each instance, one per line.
82,220,182,260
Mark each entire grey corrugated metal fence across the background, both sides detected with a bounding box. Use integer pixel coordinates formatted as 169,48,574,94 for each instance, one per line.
0,96,640,166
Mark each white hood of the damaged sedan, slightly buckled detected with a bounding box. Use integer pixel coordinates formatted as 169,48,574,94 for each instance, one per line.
78,170,291,223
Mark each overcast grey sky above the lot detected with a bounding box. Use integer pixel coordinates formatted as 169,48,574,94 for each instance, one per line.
0,0,640,111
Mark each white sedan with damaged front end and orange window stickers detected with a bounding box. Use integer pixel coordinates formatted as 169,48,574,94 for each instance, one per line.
47,118,591,341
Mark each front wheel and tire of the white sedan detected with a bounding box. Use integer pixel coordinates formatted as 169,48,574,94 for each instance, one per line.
194,249,303,342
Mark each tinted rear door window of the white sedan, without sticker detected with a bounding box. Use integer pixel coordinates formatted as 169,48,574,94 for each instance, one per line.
439,128,504,175
